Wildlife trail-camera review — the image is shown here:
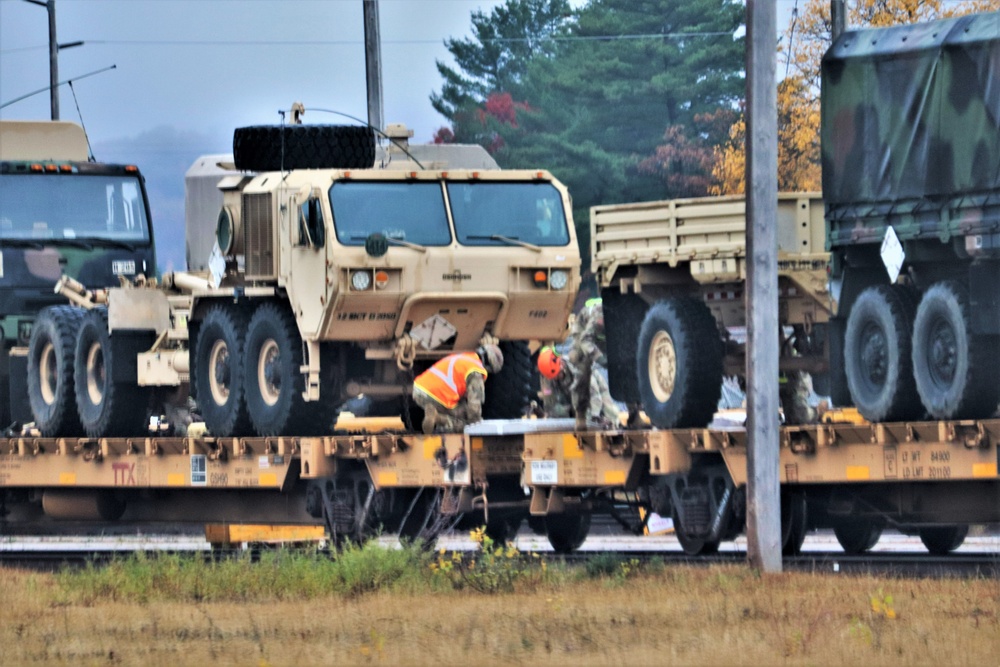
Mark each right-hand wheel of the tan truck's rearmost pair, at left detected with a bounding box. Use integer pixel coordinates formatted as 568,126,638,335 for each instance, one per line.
73,308,149,438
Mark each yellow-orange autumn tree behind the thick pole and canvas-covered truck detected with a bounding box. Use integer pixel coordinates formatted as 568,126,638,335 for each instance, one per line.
712,0,1000,194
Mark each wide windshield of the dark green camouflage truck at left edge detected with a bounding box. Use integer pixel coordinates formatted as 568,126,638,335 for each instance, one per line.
0,174,149,243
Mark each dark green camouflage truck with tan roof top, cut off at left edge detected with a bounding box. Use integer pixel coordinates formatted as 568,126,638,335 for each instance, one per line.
0,121,156,428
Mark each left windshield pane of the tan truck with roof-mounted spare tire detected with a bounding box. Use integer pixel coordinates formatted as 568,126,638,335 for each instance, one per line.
330,181,451,246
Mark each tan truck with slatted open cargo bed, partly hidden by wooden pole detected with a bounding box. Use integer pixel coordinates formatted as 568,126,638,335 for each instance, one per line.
590,193,832,428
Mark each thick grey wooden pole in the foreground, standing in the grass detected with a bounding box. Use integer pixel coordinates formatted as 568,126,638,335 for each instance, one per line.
745,0,781,572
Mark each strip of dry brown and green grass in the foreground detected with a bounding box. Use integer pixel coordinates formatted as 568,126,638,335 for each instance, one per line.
0,542,1000,665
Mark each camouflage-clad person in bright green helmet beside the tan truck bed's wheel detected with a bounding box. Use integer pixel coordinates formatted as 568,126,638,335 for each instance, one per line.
568,299,639,431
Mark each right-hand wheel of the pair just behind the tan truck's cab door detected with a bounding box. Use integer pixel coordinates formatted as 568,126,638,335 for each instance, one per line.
243,303,335,436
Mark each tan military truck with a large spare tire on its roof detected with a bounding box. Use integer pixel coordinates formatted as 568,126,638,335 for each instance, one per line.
29,124,580,437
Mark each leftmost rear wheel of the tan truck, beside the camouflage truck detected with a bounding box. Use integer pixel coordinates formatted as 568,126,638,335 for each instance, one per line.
28,306,84,438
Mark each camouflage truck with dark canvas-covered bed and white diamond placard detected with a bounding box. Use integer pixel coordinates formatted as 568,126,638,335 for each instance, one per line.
822,13,1000,421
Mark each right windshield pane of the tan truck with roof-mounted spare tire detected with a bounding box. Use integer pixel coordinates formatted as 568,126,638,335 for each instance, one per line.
448,181,569,246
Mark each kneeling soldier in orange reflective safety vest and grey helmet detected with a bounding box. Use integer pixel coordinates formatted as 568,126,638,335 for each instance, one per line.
413,345,503,435
